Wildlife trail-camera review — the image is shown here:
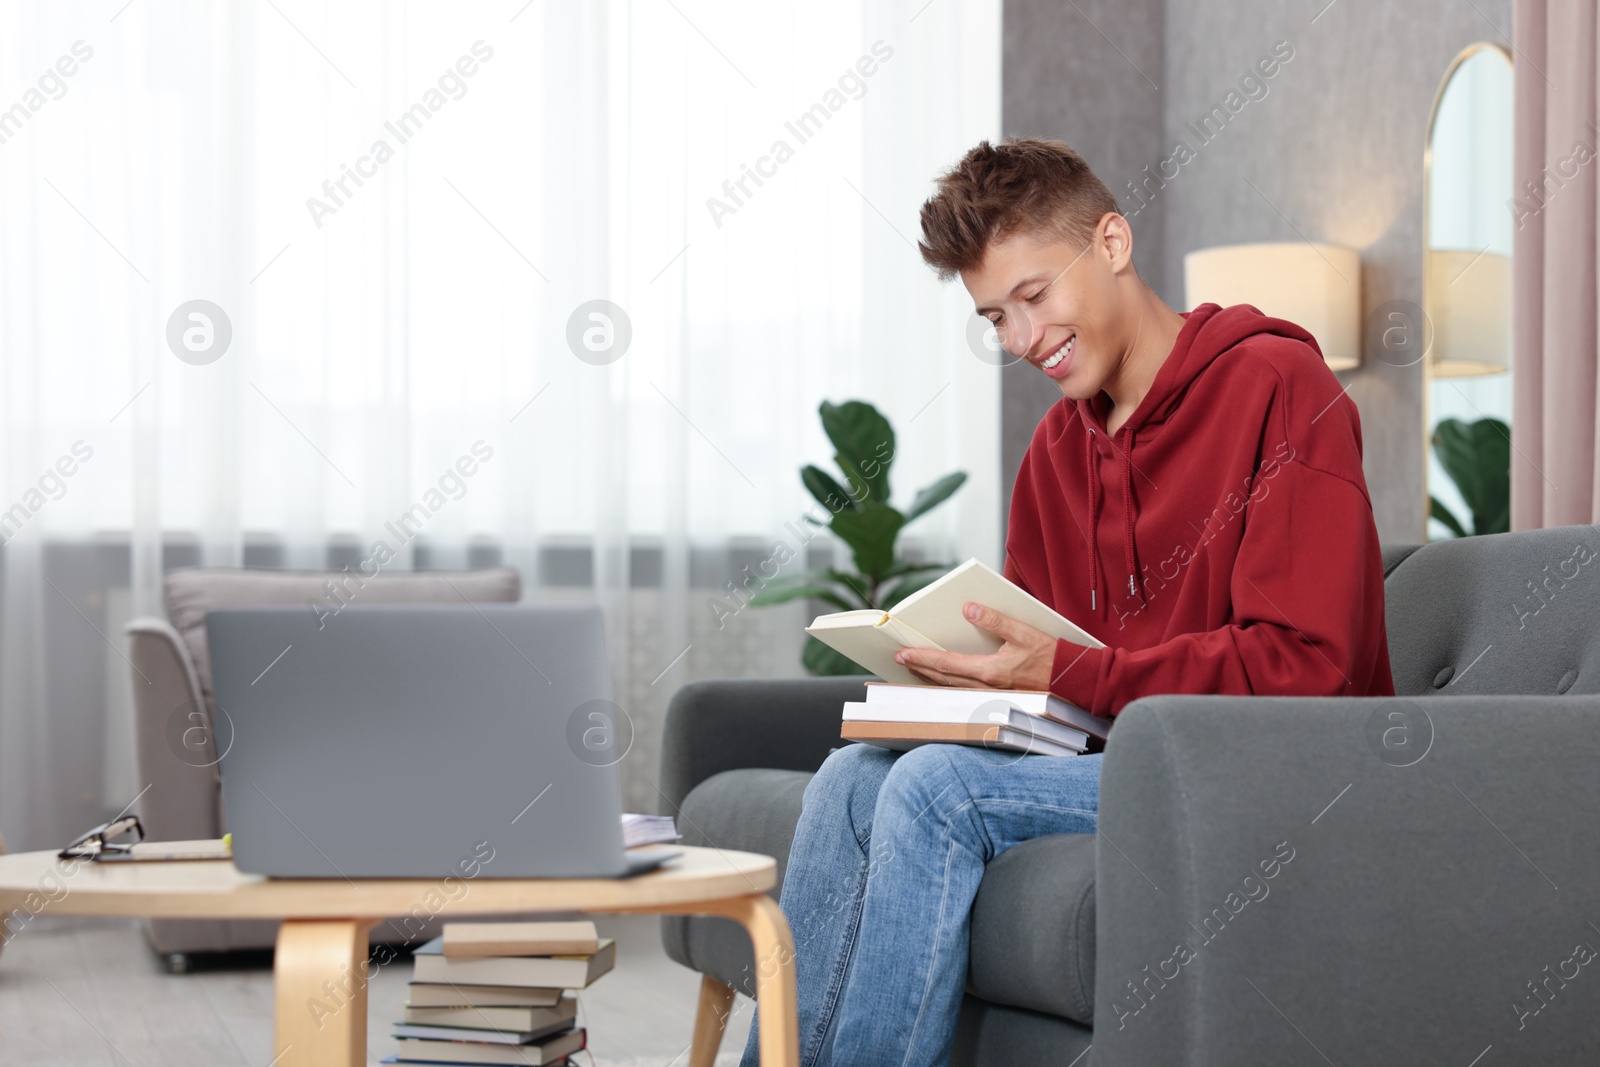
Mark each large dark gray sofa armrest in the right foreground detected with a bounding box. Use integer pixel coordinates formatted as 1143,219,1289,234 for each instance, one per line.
1094,696,1600,1067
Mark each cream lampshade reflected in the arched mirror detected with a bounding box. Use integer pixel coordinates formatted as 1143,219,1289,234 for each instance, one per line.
1427,248,1510,378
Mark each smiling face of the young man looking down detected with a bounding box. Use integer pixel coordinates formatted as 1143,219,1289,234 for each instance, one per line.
962,216,1126,400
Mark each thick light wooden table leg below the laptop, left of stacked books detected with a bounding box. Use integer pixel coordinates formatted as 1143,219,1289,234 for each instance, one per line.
272,918,378,1067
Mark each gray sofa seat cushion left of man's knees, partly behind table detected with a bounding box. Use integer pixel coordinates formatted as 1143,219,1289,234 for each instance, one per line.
661,768,811,997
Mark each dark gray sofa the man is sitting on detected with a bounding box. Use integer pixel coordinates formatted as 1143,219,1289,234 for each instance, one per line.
662,526,1600,1067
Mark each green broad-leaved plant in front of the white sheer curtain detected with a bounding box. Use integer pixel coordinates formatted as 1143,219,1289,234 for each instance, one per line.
749,400,966,675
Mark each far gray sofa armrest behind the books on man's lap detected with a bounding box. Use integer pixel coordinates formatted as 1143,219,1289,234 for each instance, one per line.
658,675,867,814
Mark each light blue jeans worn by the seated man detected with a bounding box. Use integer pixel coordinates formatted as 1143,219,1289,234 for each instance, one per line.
741,744,1101,1067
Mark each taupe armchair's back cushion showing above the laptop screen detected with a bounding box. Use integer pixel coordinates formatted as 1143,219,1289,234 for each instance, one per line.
163,566,522,713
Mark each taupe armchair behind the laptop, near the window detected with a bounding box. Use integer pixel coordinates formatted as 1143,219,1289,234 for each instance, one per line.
126,568,522,971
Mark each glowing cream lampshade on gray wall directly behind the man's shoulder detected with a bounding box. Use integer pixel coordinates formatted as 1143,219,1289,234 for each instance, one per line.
1184,242,1362,371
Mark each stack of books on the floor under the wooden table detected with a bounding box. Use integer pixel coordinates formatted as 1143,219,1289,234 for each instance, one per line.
382,921,616,1067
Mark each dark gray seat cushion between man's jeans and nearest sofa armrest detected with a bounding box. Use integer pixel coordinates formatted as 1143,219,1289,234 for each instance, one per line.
966,833,1094,1025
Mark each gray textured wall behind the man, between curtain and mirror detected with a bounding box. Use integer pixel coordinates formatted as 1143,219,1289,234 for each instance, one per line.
1002,0,1515,541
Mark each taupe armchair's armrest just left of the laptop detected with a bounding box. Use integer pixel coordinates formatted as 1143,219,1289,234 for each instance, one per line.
125,617,227,841
